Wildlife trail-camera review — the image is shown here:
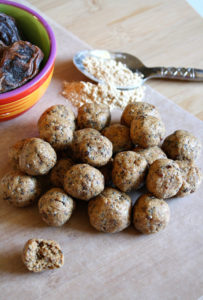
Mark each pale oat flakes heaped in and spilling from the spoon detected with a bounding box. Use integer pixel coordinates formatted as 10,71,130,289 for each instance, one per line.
62,56,144,109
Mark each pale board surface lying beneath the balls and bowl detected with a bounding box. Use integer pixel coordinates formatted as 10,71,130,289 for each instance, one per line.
0,2,203,300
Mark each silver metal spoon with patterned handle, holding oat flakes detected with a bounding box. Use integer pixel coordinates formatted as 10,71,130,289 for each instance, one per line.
73,50,203,90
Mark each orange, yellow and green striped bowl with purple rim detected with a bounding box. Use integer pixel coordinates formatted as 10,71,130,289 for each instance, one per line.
0,0,56,122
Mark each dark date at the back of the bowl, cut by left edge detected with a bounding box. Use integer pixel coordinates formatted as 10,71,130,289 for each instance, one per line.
0,13,21,48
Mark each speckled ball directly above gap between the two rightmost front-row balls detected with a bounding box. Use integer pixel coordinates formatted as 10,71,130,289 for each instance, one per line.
112,151,147,192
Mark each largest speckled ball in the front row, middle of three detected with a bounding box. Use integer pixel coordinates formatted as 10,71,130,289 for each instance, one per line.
88,188,132,233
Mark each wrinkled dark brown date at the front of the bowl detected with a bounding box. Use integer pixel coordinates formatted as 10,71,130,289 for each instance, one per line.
0,41,44,93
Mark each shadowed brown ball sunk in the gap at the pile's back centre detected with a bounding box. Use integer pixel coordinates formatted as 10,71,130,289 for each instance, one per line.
102,124,132,153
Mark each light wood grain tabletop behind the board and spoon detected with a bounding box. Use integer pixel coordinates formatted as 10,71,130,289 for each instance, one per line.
29,0,203,120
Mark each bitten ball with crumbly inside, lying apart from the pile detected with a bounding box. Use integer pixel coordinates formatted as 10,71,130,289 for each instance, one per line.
22,239,64,272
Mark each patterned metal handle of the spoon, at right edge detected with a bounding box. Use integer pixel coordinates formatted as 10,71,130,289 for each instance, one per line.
146,67,203,81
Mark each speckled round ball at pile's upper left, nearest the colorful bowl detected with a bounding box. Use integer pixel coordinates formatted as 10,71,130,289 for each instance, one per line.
38,105,75,150
